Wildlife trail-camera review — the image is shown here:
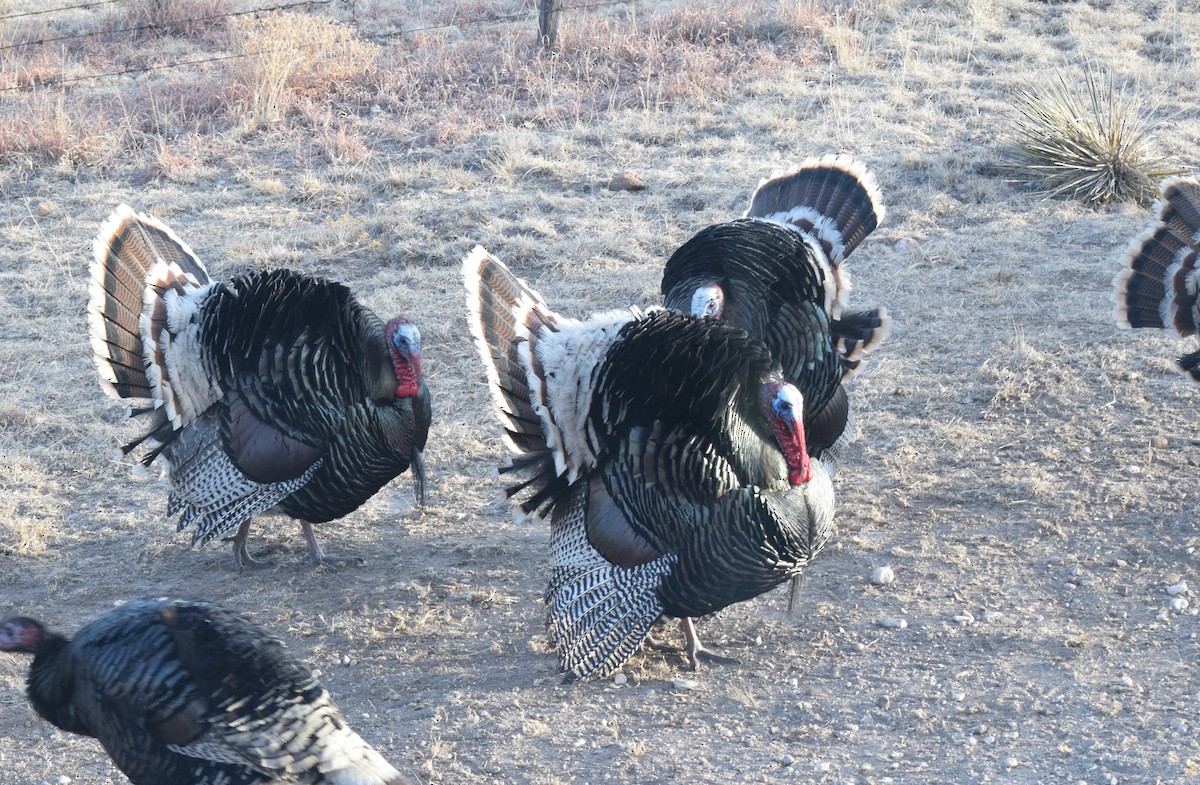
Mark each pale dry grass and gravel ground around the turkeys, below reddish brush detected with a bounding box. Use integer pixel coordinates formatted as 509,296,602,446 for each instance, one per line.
0,0,1200,785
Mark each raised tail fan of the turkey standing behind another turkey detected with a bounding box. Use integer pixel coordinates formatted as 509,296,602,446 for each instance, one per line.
746,155,884,269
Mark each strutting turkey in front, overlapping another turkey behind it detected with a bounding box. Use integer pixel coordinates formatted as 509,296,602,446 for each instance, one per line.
463,247,834,677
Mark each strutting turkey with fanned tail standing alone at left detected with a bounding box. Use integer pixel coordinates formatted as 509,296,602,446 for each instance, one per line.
88,205,431,570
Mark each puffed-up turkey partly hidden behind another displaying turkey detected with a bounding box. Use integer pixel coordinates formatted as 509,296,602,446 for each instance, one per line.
662,156,888,466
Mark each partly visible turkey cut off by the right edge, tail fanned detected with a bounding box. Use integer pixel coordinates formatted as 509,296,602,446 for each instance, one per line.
1114,176,1200,382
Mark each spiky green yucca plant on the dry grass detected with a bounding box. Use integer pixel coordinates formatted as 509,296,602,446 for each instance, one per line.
1001,67,1183,206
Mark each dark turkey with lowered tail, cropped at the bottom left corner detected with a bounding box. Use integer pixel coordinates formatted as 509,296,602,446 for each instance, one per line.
0,598,409,785
